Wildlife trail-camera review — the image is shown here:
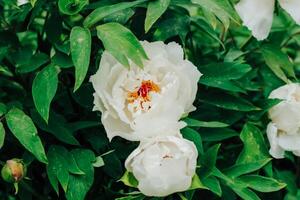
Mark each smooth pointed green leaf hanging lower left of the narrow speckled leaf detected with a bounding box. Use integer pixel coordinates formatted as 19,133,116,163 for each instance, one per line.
32,65,60,122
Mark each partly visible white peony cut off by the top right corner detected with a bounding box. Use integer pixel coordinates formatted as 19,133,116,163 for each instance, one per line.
235,0,300,40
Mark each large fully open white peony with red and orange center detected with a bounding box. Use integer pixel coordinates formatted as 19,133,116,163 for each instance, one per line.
91,42,201,141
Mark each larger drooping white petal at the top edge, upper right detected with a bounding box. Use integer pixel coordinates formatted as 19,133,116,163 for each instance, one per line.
235,0,275,40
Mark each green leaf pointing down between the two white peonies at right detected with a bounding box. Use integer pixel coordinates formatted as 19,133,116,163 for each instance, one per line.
261,45,295,83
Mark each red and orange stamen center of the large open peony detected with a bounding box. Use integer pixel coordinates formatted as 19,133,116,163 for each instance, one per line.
127,80,160,108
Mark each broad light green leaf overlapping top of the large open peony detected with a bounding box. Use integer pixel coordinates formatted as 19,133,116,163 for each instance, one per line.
97,22,147,67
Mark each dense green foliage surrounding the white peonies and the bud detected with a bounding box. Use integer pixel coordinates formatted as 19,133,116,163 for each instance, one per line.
0,0,300,200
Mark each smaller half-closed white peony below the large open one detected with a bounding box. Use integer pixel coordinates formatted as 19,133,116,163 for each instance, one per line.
125,136,198,196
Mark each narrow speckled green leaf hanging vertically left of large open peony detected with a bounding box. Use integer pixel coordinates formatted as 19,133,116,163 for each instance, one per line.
70,26,92,92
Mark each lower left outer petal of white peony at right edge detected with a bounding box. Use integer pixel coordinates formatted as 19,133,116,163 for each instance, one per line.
267,123,284,159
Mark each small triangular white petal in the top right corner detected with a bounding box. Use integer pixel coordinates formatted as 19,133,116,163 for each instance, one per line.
278,0,300,24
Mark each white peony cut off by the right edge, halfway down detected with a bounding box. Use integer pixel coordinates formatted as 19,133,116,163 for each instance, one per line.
267,83,300,158
